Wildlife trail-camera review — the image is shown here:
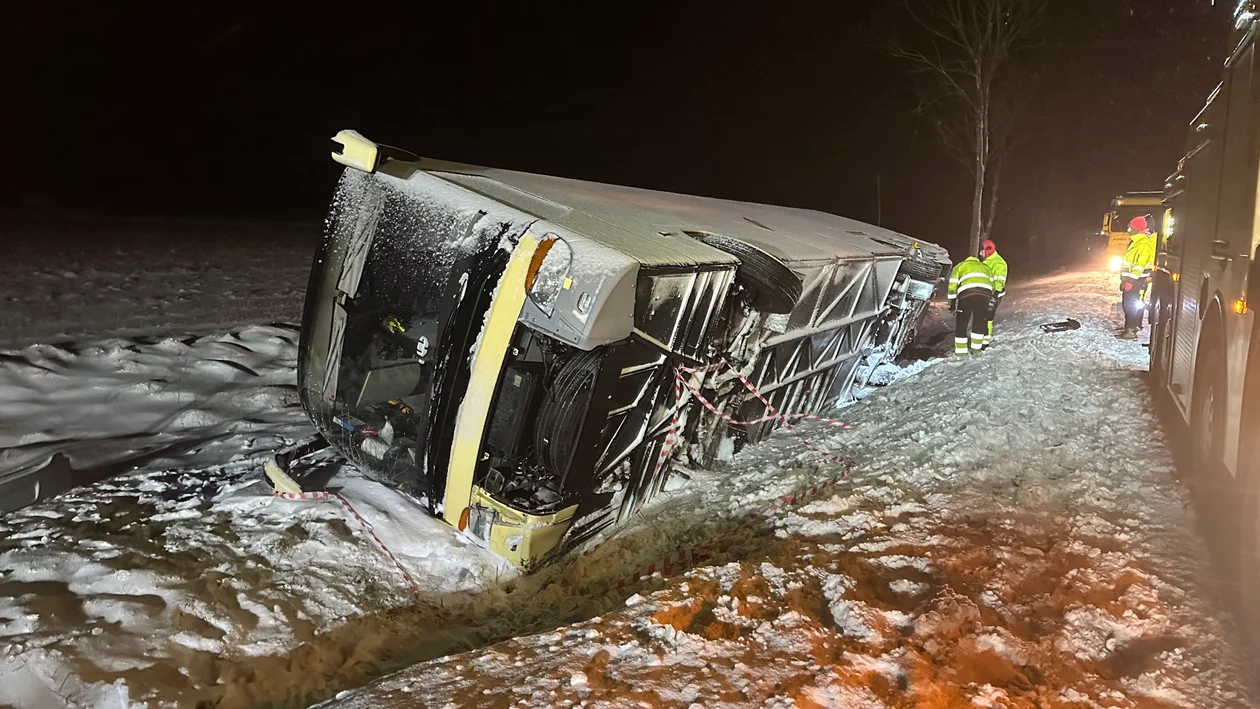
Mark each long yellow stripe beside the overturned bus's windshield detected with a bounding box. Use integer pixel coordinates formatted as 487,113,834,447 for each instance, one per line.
442,232,538,526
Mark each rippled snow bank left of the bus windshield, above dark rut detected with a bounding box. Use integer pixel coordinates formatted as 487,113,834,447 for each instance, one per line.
0,326,311,493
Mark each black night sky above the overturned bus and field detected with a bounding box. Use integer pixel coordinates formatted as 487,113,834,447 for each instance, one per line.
0,0,1232,266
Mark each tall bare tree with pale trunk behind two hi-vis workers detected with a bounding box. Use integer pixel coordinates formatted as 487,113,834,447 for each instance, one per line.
886,0,1047,253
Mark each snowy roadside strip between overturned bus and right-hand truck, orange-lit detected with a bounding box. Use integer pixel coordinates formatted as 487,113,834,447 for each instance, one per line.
334,273,1254,708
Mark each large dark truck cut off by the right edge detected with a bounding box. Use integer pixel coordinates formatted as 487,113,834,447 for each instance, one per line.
1150,1,1260,632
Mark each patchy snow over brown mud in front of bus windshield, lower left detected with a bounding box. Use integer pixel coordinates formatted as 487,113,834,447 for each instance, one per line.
0,460,512,706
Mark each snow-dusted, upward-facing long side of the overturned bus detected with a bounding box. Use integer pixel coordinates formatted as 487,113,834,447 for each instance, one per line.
372,159,948,266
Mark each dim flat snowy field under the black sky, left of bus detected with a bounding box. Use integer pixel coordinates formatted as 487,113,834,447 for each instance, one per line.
0,219,321,348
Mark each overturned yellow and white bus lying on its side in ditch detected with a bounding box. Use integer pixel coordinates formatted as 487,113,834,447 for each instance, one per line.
299,131,949,569
